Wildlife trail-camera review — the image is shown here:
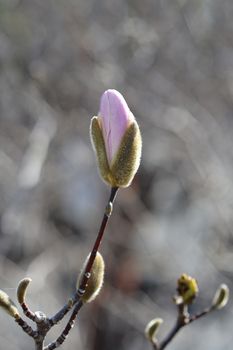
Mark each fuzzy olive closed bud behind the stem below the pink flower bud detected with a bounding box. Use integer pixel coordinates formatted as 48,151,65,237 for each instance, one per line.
77,252,105,303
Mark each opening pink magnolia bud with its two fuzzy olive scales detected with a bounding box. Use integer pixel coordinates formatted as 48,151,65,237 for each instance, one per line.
90,90,142,187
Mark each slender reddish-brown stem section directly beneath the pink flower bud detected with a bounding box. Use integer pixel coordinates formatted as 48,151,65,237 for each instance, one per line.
74,187,118,302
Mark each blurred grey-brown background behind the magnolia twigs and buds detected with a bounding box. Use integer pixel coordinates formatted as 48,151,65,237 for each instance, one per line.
0,0,233,350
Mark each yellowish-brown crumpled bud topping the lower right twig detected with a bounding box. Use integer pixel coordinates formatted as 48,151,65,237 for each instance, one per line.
177,273,198,305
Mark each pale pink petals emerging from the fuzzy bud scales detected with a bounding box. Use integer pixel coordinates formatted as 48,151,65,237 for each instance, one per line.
100,89,134,164
